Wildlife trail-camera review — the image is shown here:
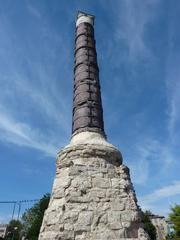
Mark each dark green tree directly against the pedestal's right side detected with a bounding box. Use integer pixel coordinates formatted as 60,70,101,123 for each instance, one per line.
142,211,157,240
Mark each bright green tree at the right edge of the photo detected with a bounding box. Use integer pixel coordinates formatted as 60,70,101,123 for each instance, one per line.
169,204,180,240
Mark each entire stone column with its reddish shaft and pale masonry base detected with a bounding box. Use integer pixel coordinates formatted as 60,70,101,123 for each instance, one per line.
39,13,148,240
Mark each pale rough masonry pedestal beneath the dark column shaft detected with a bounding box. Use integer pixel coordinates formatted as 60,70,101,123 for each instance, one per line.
39,133,148,240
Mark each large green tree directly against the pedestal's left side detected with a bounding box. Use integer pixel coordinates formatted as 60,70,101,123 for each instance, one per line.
22,194,50,240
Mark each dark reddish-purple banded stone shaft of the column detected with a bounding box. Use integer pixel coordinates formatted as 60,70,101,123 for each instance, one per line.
72,19,105,135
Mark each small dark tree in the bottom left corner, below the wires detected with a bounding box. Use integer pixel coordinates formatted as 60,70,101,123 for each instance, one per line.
5,220,22,240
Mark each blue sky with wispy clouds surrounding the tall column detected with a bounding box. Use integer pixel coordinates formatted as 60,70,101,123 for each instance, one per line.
0,0,180,222
